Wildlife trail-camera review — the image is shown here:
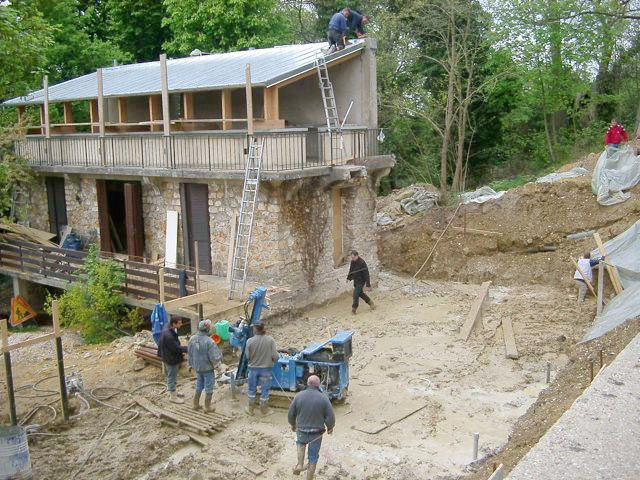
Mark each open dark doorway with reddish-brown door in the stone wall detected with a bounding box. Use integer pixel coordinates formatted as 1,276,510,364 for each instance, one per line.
96,180,144,258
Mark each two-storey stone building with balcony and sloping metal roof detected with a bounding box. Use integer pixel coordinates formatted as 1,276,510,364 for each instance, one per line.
0,39,394,312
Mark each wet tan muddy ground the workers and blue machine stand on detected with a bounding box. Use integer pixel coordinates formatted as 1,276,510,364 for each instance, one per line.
2,273,594,480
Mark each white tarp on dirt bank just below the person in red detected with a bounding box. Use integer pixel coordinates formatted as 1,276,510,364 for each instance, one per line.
591,145,640,205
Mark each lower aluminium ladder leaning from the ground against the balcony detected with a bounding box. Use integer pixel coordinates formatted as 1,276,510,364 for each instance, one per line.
229,136,264,299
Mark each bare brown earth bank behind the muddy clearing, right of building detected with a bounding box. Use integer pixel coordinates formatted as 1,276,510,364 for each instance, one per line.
378,154,640,287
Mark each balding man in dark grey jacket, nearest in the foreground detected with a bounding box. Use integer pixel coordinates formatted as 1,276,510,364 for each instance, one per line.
288,375,336,480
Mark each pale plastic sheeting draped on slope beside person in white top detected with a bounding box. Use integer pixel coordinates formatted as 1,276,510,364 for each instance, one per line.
582,221,640,342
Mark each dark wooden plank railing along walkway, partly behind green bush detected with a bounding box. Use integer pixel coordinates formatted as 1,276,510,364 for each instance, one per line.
0,241,196,301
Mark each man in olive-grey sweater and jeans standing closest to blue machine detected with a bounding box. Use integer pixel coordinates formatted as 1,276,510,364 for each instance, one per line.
245,322,280,415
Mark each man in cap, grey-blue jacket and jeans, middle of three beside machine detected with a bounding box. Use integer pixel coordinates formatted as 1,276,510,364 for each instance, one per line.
187,320,222,412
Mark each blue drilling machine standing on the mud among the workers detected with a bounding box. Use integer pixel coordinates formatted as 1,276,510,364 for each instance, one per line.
229,287,353,402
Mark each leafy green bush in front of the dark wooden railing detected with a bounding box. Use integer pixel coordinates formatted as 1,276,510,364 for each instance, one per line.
47,245,143,343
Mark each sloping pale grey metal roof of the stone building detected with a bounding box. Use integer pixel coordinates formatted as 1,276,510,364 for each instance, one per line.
2,40,366,106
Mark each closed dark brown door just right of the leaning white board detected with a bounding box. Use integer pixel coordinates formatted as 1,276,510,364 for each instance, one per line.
182,183,211,274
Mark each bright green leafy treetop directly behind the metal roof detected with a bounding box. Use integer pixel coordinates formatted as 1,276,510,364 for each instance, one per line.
163,0,293,55
